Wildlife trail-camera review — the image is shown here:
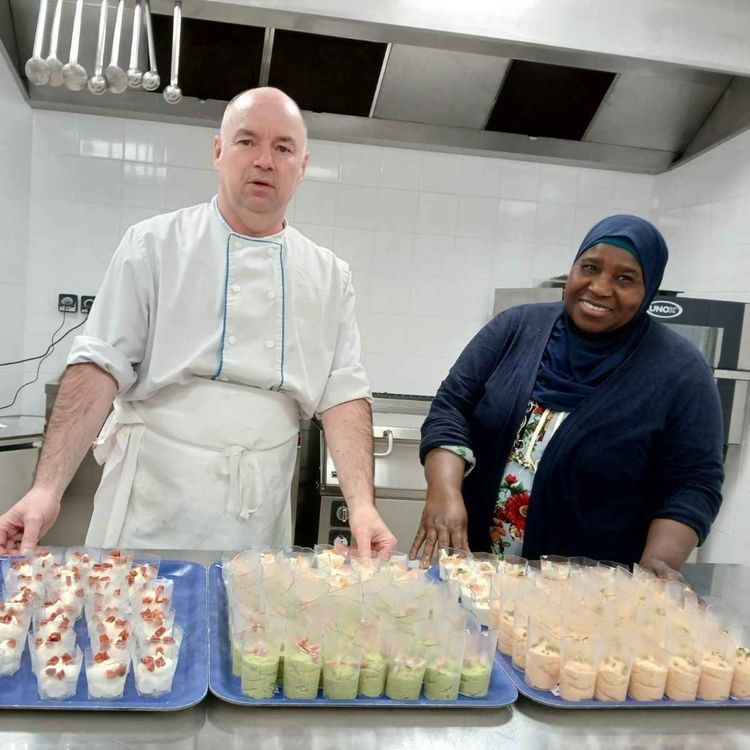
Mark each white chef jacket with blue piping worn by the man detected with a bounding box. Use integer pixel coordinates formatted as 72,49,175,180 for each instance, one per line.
67,198,370,417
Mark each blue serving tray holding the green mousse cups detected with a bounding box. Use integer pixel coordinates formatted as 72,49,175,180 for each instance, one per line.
208,563,518,708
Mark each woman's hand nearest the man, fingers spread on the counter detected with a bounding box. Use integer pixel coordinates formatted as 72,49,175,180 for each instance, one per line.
409,485,469,568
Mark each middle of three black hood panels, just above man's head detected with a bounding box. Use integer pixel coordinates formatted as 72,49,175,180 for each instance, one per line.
268,29,388,117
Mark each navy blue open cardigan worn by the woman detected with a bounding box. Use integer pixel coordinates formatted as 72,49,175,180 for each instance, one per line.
420,302,724,563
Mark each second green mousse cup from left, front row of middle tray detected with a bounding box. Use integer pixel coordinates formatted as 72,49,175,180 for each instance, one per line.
283,617,323,699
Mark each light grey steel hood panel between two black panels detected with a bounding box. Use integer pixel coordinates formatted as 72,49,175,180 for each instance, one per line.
375,44,510,130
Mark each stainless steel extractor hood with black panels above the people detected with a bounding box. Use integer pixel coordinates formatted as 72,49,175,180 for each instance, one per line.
0,0,750,173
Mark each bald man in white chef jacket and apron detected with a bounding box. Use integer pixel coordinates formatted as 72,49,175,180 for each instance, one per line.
0,88,395,556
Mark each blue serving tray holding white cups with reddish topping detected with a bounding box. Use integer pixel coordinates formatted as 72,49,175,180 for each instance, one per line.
0,560,208,711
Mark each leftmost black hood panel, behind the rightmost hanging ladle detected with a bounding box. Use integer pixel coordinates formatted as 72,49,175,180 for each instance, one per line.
152,13,265,101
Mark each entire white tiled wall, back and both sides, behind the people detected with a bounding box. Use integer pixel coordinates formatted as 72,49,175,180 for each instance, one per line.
5,66,750,563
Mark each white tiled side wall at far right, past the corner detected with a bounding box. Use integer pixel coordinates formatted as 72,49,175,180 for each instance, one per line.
653,130,750,565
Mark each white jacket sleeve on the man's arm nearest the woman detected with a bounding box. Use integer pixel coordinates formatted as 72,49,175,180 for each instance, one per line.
316,269,372,414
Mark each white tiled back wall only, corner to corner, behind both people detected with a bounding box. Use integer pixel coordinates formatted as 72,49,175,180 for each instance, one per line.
16,111,654,409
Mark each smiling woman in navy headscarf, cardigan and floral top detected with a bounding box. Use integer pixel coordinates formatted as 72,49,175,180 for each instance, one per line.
412,215,723,576
